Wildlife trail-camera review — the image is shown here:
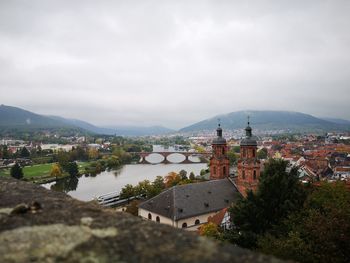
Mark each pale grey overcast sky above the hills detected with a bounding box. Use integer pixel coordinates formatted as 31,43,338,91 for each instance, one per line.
0,0,350,128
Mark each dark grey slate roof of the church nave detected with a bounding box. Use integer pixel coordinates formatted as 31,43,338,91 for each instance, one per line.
139,179,240,221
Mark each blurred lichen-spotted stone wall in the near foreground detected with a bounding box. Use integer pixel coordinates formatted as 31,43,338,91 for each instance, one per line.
0,178,280,263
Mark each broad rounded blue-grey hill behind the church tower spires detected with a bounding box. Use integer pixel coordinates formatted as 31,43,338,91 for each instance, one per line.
180,111,350,132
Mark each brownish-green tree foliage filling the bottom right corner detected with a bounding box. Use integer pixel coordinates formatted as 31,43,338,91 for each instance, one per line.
258,182,350,262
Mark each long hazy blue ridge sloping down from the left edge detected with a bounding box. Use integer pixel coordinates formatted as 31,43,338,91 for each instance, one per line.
0,105,173,136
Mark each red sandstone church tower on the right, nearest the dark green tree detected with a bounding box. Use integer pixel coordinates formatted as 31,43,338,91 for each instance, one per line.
236,117,260,196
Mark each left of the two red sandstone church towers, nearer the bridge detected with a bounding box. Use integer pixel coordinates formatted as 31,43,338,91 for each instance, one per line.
209,124,230,180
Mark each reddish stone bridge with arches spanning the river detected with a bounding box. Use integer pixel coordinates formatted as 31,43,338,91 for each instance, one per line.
135,152,212,164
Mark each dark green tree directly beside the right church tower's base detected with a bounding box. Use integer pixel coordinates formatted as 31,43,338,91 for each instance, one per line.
229,159,306,248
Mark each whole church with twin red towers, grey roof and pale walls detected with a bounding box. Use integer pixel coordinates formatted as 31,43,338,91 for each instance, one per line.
138,121,260,231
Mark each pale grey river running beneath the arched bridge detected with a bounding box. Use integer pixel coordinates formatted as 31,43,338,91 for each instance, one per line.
42,146,207,201
